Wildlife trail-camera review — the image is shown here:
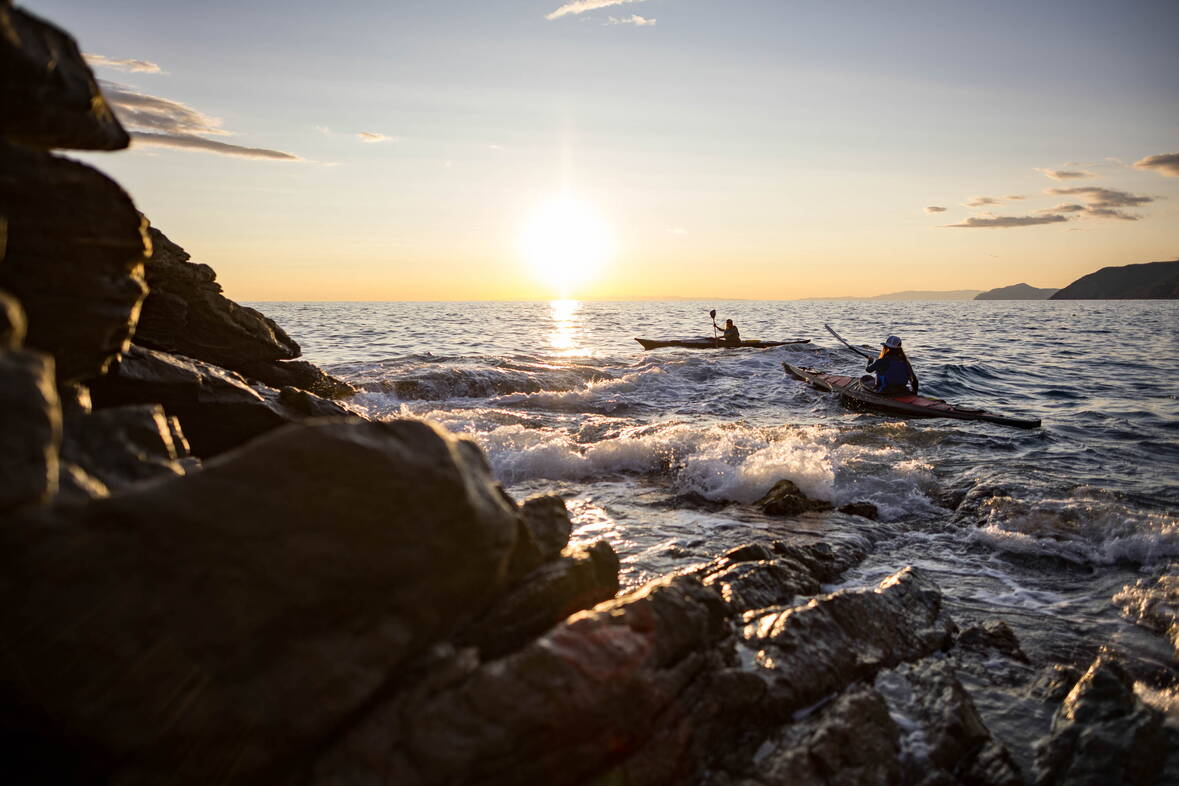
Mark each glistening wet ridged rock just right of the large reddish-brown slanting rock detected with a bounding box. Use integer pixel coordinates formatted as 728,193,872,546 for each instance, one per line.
742,567,954,716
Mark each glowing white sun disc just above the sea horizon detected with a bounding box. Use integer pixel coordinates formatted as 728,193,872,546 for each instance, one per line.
521,193,612,298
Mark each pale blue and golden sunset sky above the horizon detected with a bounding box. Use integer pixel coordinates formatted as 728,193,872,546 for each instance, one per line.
41,0,1179,300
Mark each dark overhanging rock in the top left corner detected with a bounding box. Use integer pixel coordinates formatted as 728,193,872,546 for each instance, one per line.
0,0,130,150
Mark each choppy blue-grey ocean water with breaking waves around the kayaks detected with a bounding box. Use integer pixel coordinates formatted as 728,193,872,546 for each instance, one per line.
255,300,1179,688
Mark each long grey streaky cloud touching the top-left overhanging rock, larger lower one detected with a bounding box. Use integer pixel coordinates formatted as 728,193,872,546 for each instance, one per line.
99,80,301,161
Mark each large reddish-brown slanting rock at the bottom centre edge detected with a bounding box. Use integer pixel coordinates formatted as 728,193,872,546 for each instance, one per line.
311,576,749,786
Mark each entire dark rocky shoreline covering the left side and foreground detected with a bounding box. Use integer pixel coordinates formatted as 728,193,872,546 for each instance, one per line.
0,0,1179,786
